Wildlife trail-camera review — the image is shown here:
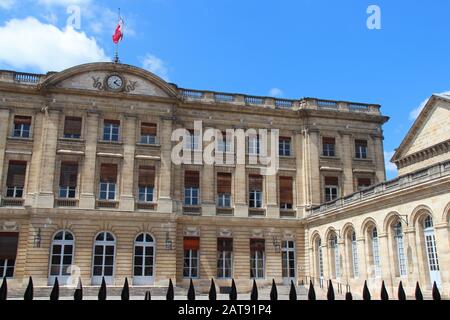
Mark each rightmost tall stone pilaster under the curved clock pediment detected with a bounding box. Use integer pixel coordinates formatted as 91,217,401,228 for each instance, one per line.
158,117,173,213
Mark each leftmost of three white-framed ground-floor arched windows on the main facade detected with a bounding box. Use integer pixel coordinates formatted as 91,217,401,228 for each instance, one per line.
48,230,75,285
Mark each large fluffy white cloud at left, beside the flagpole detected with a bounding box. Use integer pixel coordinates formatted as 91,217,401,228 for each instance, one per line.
0,17,110,72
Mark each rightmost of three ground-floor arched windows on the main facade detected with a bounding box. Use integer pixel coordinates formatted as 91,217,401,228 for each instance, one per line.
133,233,155,284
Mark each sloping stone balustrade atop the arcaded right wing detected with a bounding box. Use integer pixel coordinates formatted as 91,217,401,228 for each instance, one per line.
308,161,450,215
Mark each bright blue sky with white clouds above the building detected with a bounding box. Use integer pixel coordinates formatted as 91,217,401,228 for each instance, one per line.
0,0,450,177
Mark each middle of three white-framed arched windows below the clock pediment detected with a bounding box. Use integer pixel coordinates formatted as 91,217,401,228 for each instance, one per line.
92,231,116,284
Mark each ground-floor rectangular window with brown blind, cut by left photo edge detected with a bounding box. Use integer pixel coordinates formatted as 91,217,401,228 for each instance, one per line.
0,232,19,278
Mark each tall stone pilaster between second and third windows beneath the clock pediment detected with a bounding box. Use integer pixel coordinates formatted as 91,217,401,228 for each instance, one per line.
119,115,136,211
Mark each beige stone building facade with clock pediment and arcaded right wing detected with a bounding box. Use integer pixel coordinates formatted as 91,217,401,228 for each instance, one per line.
0,63,449,298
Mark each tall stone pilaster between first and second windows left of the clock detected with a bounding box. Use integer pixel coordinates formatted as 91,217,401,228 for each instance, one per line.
80,112,99,209
